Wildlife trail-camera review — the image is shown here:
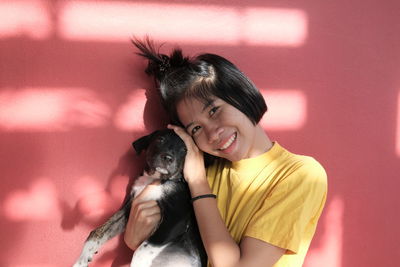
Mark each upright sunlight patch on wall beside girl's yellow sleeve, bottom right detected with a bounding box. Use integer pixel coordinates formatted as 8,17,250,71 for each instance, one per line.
305,197,344,267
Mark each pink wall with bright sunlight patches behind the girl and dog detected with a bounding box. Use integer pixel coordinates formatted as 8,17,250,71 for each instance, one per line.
0,0,400,267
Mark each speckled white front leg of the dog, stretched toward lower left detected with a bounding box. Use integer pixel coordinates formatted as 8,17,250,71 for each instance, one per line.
73,198,132,267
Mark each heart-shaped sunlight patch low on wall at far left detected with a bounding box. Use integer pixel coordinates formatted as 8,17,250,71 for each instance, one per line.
3,178,59,221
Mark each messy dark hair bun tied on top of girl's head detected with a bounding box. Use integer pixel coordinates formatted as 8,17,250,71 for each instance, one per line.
132,37,189,84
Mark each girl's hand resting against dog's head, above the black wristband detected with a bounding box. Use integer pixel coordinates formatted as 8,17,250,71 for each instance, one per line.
168,124,206,184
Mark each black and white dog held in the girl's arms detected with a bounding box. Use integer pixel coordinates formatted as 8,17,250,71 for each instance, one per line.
73,129,207,267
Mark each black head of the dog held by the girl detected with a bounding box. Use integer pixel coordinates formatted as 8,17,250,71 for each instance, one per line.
132,129,186,180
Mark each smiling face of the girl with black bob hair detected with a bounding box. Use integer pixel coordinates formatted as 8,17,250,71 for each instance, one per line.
177,97,259,161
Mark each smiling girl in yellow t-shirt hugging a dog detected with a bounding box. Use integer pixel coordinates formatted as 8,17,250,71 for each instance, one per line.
125,40,327,267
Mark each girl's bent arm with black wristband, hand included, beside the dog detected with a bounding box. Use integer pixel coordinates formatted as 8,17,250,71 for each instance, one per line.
169,126,285,267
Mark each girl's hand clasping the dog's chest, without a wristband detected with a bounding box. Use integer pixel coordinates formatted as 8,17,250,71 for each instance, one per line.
124,184,161,250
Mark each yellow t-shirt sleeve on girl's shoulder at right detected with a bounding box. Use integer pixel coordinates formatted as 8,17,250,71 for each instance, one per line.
244,159,327,253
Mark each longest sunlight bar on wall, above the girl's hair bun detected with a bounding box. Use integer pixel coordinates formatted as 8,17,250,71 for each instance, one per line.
59,1,308,46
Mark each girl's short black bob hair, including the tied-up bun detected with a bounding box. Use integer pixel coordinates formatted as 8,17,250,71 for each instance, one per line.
132,38,267,125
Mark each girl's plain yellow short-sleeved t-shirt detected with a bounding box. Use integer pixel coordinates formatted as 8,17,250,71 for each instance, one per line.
207,142,327,267
